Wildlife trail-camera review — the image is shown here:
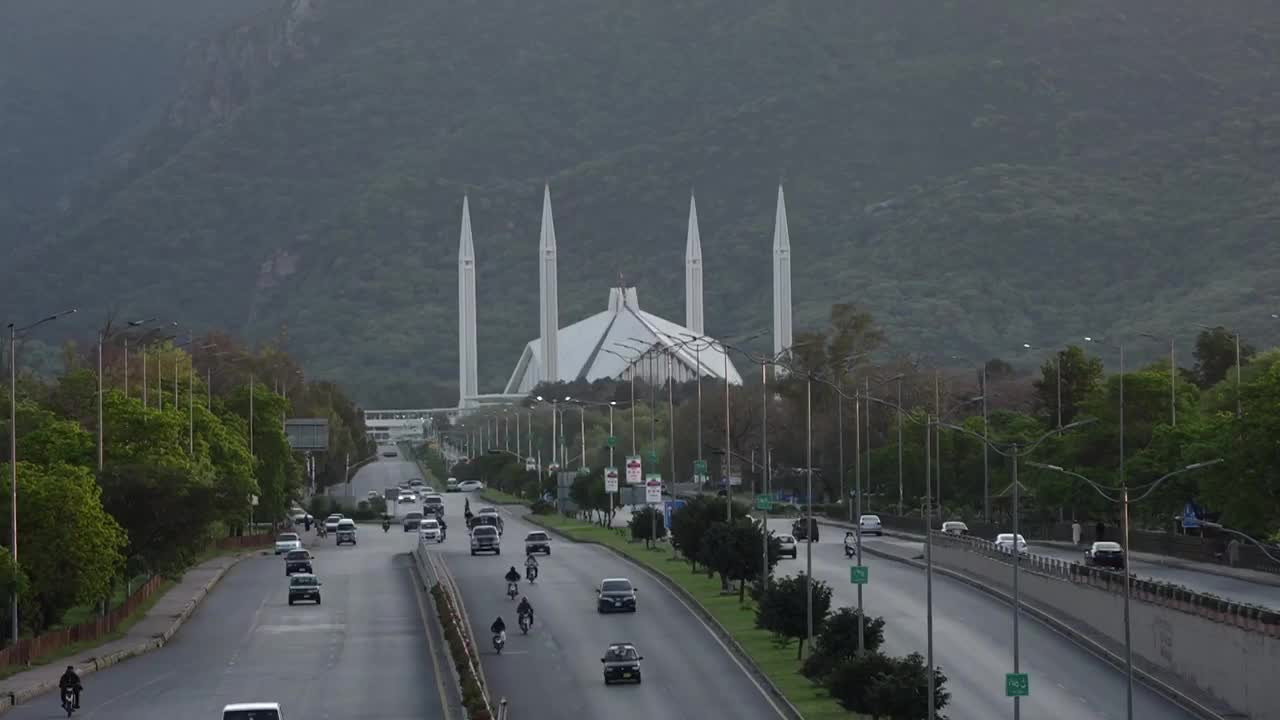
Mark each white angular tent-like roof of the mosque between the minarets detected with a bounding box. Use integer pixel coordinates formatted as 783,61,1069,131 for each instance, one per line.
504,287,742,393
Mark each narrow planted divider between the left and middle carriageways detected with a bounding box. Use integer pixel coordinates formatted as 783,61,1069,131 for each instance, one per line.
413,542,494,720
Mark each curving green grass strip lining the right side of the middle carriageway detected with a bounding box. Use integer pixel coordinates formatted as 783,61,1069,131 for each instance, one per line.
524,514,856,720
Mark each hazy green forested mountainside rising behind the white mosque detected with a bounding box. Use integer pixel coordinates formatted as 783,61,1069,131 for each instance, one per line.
0,0,1280,405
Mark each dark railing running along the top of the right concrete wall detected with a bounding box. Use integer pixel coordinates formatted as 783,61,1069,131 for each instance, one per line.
932,530,1280,638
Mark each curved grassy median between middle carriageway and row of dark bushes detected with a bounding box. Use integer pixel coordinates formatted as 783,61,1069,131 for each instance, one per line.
525,515,860,720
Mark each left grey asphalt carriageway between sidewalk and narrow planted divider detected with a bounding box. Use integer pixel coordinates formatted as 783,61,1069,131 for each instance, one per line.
6,462,448,720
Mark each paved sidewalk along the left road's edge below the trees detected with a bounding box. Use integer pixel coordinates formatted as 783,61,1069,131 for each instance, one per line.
0,551,257,714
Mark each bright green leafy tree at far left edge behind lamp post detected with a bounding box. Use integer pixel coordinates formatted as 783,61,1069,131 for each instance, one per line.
0,462,127,632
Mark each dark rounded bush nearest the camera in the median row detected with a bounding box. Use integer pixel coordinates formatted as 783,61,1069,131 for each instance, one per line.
826,652,951,720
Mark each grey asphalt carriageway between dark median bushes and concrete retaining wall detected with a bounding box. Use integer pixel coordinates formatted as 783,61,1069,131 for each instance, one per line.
769,520,1194,720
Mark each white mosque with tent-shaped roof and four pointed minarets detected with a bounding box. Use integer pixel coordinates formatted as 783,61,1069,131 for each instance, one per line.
458,187,792,409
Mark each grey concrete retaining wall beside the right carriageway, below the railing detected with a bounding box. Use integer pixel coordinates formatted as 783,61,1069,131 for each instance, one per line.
933,533,1280,720
